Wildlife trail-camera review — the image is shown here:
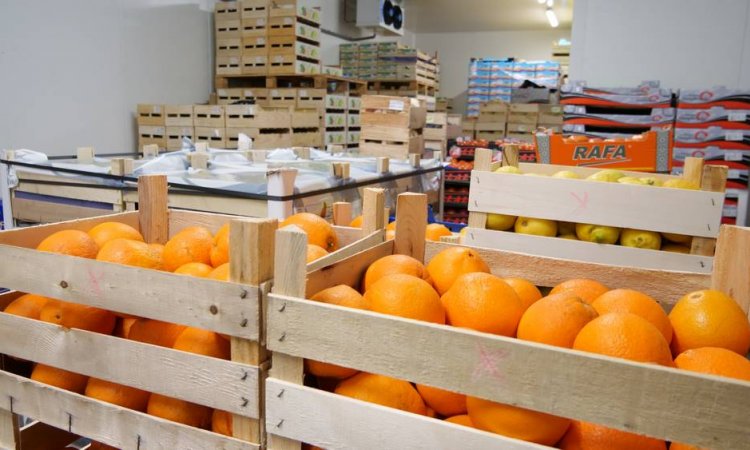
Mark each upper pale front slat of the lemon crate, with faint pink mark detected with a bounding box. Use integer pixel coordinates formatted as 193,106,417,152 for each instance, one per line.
469,170,724,238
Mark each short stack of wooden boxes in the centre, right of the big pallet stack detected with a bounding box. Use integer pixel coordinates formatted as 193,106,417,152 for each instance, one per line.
359,95,427,159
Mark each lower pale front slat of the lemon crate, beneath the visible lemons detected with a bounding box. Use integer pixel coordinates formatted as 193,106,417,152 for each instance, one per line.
462,228,713,275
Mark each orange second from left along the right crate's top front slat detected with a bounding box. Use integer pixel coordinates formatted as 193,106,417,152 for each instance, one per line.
365,274,445,324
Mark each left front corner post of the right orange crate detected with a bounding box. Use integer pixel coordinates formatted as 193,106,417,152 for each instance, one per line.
266,226,307,450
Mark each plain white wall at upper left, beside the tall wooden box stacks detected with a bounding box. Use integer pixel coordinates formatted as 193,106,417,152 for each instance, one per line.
0,0,212,155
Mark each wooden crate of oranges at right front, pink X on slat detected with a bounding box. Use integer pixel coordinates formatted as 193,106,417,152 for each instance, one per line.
266,194,750,450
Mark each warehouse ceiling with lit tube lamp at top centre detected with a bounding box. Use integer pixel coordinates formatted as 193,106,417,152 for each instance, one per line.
406,0,573,33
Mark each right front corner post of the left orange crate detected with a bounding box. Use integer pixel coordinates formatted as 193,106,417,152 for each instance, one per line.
229,219,278,445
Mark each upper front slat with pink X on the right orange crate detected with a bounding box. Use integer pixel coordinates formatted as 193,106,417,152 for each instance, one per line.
268,294,750,448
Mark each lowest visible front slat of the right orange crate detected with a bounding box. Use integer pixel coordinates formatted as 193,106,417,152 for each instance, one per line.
266,378,549,450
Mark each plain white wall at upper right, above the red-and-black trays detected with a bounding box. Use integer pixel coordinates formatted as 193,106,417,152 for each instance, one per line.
570,0,750,88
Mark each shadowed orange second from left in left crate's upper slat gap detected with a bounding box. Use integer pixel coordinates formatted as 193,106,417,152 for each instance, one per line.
39,300,117,334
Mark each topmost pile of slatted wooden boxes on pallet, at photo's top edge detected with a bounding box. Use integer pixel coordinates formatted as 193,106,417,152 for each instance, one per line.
215,0,320,76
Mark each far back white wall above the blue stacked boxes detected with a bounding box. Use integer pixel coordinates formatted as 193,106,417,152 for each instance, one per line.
416,28,579,113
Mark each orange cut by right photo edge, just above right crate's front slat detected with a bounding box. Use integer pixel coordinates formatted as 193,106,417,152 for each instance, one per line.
674,347,750,381
